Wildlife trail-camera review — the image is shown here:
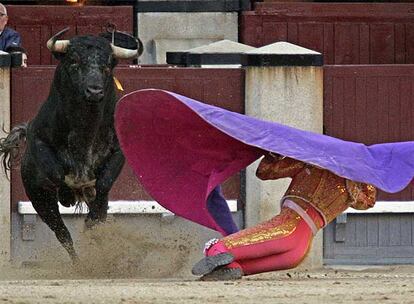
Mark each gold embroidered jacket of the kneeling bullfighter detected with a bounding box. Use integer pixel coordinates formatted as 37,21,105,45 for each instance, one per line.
256,155,376,225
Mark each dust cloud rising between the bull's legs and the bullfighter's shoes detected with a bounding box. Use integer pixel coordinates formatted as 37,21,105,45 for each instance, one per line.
72,222,194,278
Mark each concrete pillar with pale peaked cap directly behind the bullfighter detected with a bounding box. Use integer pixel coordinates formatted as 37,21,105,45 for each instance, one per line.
243,42,323,267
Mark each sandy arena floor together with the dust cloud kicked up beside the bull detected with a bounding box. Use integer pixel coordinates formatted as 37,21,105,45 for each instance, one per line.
0,223,414,304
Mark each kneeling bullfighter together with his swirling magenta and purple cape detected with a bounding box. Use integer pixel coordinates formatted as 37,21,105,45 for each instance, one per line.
115,89,414,279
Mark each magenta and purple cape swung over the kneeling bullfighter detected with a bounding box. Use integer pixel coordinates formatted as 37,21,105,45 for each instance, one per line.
115,90,414,232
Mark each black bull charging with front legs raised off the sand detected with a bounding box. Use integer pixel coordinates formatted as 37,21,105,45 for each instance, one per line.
0,30,142,261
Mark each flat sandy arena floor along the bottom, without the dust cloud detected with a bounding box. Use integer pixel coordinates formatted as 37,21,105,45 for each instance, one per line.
0,266,414,304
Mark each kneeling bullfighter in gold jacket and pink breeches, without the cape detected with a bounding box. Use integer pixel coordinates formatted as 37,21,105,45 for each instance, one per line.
193,153,376,280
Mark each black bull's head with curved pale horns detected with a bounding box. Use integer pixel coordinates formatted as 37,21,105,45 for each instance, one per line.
47,28,142,104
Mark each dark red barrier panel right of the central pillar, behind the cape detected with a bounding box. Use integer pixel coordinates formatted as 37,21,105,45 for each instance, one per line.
324,65,414,201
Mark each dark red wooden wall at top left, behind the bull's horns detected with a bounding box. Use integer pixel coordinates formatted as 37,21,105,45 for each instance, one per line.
7,5,133,65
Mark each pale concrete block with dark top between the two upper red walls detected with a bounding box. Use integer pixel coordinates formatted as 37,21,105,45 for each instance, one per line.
136,0,249,64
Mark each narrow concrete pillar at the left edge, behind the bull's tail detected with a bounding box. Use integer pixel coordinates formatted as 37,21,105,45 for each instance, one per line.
0,51,11,266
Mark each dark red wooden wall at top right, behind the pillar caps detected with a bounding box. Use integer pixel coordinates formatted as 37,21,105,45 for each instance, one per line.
240,2,414,64
